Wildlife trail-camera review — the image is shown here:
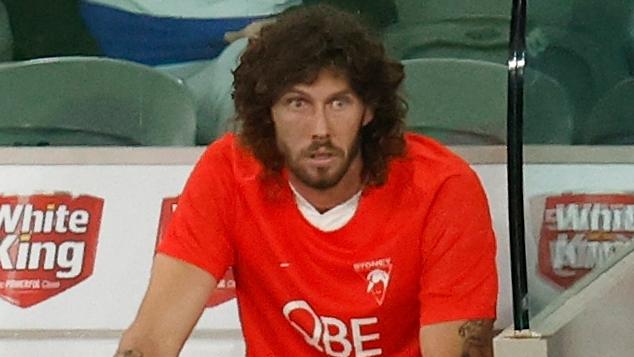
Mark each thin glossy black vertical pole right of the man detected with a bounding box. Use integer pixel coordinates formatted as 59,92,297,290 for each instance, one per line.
507,0,529,331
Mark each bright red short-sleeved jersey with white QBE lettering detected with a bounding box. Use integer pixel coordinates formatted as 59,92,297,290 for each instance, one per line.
158,134,497,357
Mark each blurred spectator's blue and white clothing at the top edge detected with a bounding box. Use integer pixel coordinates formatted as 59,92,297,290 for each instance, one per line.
81,0,300,65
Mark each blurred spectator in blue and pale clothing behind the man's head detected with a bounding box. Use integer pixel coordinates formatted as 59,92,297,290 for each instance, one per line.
80,0,301,145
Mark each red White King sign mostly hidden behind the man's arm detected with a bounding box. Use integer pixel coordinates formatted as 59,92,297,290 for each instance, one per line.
156,197,236,307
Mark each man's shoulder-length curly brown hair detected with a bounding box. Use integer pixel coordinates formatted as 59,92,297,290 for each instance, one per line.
233,5,407,185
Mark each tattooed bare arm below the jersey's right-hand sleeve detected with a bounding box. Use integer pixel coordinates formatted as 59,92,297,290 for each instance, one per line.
420,320,493,357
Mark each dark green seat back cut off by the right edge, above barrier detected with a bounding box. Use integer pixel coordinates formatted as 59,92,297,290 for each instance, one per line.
575,78,634,145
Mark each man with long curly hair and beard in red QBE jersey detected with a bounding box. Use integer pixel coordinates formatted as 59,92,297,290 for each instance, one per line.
117,6,497,357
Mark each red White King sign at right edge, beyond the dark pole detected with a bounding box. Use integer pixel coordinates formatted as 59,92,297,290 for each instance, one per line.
538,194,634,288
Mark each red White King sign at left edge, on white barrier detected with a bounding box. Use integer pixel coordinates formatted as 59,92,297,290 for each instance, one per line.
0,193,103,308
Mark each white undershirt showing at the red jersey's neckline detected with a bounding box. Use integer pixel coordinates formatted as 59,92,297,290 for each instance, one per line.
288,182,361,232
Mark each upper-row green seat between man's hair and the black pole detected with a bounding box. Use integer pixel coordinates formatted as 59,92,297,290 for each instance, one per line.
383,0,511,64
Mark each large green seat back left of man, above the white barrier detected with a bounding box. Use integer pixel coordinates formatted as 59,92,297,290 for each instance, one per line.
0,57,196,146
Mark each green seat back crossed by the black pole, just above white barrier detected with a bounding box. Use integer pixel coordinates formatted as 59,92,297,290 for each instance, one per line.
403,58,573,145
